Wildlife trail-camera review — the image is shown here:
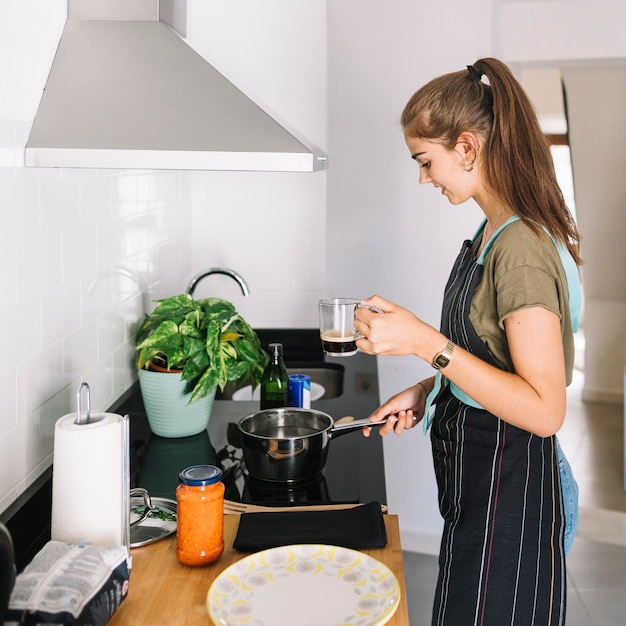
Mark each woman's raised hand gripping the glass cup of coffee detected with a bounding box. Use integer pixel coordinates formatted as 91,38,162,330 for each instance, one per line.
354,296,446,358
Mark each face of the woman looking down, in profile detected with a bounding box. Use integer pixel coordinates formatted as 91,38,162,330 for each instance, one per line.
405,136,475,204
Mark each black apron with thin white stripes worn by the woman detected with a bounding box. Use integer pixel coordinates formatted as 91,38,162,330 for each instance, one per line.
431,235,566,626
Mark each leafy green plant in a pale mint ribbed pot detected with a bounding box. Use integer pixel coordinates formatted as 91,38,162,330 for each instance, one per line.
135,294,269,437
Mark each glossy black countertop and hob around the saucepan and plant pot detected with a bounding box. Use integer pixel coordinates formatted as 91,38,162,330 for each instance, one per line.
127,329,386,504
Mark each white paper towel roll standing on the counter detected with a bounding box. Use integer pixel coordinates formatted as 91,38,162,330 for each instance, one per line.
52,413,128,546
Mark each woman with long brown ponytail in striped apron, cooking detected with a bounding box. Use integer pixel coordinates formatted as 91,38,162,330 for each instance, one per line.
356,58,580,626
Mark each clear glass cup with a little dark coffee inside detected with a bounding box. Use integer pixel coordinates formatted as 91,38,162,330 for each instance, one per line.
318,298,360,356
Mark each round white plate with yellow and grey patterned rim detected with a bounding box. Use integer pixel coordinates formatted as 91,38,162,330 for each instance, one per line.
207,544,400,626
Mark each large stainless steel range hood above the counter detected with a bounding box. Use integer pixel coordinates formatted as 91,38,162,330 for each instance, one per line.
25,0,326,172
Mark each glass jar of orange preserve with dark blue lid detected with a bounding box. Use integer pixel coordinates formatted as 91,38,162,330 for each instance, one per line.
176,465,224,565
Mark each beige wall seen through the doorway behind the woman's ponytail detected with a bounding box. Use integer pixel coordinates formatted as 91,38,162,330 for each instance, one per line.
563,66,626,403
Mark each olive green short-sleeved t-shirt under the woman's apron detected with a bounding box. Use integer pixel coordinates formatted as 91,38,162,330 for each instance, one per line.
470,220,574,385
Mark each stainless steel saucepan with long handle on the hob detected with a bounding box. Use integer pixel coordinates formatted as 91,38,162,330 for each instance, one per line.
238,407,387,483
